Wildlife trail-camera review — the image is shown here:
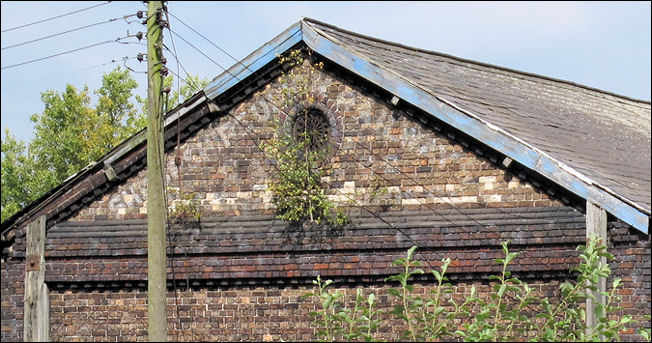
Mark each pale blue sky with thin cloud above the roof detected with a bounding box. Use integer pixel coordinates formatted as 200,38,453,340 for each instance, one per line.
0,1,651,142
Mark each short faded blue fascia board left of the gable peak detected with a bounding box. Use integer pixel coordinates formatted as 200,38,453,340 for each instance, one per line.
204,22,303,100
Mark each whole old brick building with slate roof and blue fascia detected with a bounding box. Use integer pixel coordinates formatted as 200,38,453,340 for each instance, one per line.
2,19,651,341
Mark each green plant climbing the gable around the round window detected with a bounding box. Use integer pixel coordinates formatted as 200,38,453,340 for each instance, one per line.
264,50,347,225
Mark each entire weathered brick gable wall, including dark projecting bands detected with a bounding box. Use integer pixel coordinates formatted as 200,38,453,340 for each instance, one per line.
2,59,651,341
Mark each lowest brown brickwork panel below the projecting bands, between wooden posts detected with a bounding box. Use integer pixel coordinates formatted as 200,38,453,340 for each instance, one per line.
50,282,558,342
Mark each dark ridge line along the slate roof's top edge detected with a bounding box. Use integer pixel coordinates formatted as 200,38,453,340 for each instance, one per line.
301,17,652,105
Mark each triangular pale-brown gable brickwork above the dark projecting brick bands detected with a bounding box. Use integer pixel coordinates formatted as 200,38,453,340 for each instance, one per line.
71,60,560,220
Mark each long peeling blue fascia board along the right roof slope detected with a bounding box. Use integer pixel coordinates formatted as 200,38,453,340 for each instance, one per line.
301,21,649,233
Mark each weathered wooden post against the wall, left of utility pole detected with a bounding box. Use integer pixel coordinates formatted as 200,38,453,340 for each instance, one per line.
23,216,50,342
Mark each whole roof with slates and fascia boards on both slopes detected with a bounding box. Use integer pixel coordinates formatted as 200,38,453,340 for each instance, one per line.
2,18,651,238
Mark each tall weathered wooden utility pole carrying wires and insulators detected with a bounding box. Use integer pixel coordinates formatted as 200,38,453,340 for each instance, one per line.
147,1,167,342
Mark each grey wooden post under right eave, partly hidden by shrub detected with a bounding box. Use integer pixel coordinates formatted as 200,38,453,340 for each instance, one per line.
586,201,607,338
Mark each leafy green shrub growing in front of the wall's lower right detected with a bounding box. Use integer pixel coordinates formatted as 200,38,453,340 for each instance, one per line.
307,237,650,342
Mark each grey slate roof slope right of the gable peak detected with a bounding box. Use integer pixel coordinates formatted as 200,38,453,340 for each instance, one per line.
305,19,651,213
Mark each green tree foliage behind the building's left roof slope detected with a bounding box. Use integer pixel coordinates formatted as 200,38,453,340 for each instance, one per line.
2,66,208,221
